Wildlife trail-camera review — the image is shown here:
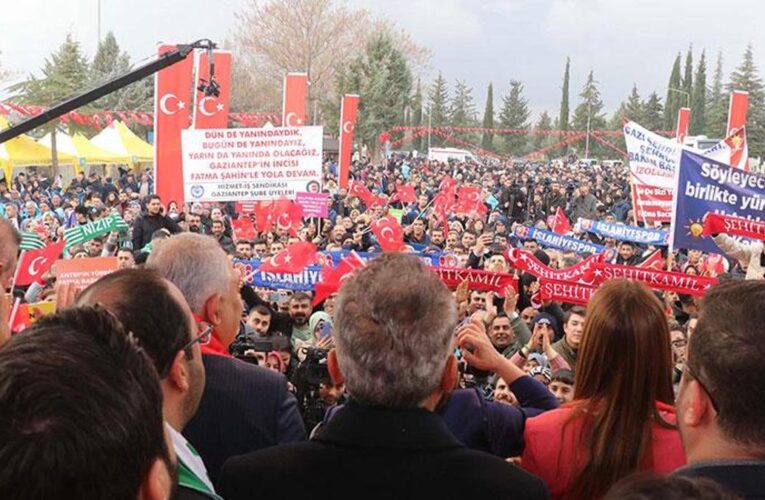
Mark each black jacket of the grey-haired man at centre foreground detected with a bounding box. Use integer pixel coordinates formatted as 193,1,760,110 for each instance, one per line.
218,402,548,500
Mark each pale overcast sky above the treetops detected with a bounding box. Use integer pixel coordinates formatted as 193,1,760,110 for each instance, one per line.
0,0,765,115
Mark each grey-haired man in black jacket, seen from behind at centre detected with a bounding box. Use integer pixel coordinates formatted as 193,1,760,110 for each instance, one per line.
219,254,547,500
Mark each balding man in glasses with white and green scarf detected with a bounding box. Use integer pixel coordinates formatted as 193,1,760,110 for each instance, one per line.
77,269,219,499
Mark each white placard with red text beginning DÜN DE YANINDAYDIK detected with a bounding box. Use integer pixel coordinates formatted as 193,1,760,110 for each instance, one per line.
182,127,322,202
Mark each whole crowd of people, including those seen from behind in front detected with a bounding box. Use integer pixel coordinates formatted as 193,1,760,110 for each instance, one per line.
0,156,765,499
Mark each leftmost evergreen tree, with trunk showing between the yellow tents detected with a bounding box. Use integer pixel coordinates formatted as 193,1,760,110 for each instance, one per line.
13,35,89,173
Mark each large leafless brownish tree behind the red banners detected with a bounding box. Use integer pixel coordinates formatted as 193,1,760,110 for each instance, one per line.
232,0,430,118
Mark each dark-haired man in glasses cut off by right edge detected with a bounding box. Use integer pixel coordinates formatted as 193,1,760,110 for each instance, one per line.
676,280,765,498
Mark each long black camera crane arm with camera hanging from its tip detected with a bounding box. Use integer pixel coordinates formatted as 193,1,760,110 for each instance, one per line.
0,39,220,144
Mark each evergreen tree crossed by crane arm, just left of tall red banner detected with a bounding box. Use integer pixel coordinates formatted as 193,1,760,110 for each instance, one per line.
90,31,154,111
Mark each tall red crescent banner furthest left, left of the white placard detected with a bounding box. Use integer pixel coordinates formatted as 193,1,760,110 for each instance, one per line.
154,45,194,205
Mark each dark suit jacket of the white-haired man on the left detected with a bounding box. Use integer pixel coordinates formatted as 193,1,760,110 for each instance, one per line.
183,354,306,483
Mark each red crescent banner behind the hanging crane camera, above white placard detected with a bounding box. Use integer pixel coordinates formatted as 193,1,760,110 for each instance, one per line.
194,50,231,128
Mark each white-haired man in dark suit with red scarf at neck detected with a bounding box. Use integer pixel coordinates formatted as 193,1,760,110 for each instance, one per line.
148,233,306,483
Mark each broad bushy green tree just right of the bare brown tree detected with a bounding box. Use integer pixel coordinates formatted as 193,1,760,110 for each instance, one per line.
337,34,412,152
